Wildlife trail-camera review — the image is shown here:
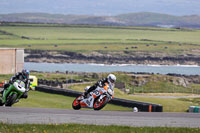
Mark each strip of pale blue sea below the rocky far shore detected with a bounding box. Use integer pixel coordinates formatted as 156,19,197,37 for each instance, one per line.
24,62,200,75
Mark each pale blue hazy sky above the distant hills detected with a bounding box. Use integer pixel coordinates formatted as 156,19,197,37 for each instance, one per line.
0,0,200,16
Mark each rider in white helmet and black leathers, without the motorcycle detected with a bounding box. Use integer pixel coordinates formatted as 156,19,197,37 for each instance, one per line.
83,74,117,98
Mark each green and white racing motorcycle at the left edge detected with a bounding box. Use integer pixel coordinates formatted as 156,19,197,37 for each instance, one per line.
0,80,26,106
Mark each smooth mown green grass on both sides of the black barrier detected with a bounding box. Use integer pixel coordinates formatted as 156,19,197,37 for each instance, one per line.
14,86,200,112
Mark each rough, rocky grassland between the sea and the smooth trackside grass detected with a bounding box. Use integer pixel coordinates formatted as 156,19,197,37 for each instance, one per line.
0,72,200,94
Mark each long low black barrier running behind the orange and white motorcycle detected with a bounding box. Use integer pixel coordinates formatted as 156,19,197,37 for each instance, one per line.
35,85,163,112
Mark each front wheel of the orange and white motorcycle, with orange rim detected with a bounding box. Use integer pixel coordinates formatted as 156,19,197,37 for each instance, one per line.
93,96,108,110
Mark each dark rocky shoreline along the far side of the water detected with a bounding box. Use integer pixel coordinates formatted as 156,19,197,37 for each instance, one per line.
25,50,200,66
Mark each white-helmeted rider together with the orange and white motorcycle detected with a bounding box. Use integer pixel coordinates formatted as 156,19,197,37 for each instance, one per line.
72,74,116,110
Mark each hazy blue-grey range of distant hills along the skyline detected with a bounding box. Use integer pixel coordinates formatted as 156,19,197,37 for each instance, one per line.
0,12,200,28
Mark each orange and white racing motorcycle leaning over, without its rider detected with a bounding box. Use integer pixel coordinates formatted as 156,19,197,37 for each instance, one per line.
72,83,114,110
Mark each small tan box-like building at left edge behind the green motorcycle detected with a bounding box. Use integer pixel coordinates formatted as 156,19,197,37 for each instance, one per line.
0,48,24,74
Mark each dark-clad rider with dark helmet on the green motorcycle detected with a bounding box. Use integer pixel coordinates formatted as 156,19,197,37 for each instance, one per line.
1,69,30,98
